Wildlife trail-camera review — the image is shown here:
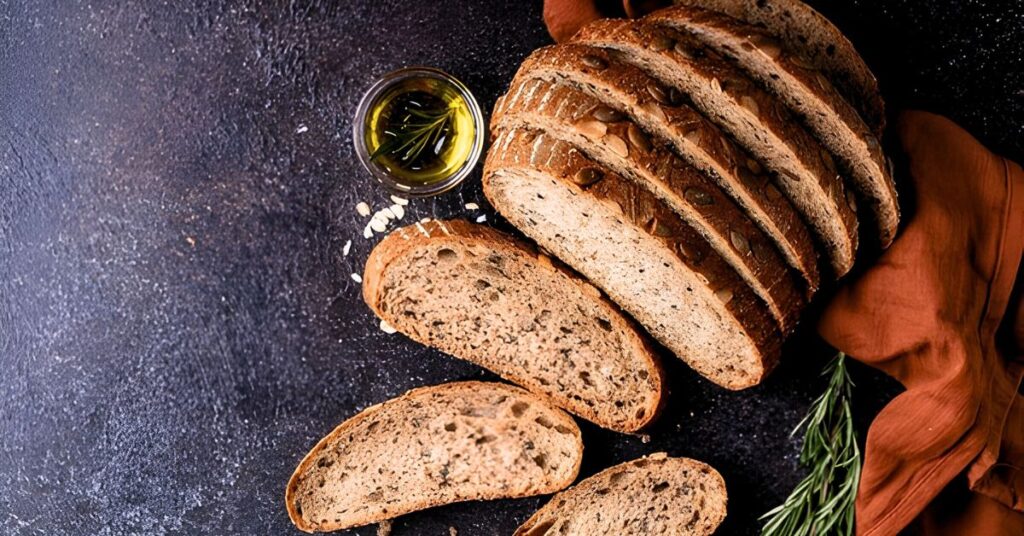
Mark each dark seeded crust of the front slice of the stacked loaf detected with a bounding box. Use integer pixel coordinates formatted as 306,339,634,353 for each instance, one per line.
483,128,783,389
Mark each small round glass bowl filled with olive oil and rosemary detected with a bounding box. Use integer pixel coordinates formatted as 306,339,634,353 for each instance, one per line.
352,67,485,197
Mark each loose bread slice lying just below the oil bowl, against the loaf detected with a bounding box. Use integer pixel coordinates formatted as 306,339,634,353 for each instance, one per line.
362,220,663,431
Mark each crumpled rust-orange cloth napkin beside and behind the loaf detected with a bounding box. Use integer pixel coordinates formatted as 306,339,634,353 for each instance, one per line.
544,5,1024,536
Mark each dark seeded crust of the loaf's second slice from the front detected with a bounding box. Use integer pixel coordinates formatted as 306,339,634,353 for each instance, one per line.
499,79,807,332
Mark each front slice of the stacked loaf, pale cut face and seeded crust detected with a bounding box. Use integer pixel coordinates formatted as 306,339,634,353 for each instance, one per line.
483,129,782,389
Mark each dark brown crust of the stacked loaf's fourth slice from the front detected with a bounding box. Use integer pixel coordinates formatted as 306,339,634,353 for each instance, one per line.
573,19,857,275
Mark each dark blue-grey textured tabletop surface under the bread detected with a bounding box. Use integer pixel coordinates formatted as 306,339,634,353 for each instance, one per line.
0,0,1024,535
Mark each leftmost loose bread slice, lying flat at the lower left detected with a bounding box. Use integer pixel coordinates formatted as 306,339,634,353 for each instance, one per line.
285,381,583,532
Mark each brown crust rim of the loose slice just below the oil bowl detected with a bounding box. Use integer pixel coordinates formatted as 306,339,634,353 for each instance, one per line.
362,219,666,432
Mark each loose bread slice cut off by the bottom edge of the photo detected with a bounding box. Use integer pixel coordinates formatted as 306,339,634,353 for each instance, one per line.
515,452,728,536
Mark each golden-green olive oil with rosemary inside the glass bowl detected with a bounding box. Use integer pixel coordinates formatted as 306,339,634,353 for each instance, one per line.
364,77,479,185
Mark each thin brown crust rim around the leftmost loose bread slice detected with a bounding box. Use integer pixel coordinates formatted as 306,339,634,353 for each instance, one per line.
285,381,584,533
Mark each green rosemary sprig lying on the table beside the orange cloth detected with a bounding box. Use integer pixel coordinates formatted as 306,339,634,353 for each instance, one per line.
761,353,860,536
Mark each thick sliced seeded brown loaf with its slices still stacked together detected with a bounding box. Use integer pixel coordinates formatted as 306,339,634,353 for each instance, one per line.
483,0,899,389
